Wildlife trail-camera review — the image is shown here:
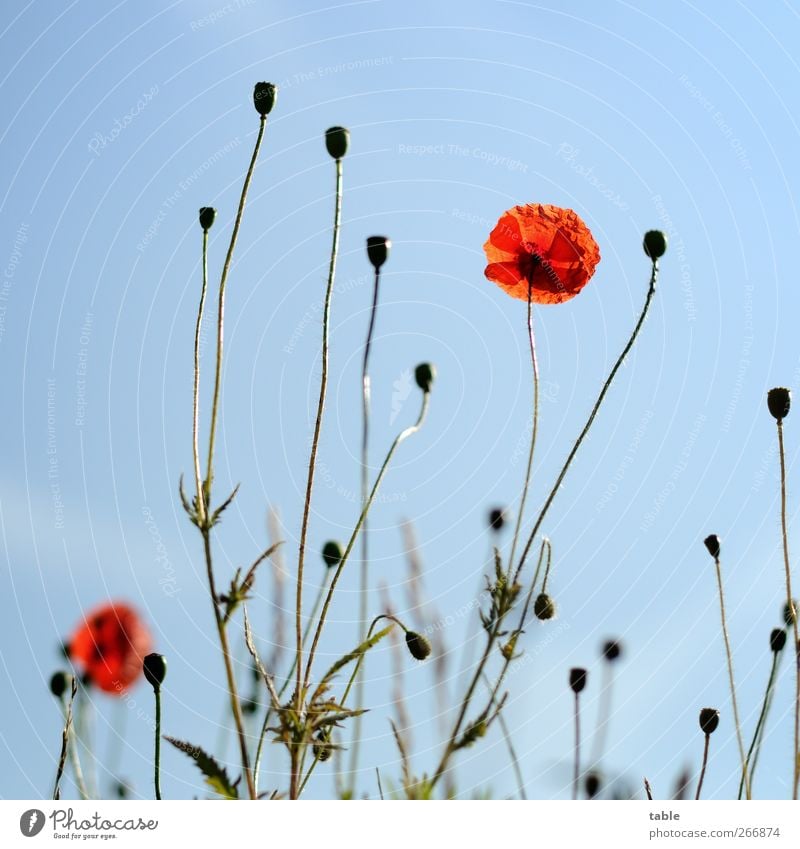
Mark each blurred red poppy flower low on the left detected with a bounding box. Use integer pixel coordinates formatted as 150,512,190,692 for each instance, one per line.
67,602,152,695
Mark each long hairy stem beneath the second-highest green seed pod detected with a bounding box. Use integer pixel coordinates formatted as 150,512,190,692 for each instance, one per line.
293,159,342,724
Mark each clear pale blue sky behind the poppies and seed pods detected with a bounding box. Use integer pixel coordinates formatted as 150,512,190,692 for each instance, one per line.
0,0,800,798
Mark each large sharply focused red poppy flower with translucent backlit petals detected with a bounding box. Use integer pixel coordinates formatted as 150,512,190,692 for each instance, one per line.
483,203,600,304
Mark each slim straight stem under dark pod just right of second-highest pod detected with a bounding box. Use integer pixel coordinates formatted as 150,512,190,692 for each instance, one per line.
350,268,381,793
